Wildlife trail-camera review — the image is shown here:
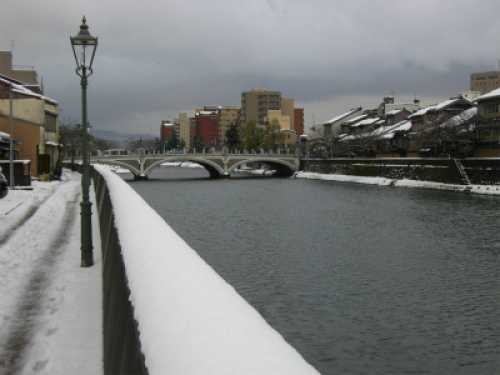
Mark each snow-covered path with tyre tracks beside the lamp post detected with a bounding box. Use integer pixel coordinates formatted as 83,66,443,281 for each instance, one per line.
0,170,103,375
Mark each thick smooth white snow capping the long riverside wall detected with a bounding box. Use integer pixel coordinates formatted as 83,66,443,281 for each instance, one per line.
95,165,318,375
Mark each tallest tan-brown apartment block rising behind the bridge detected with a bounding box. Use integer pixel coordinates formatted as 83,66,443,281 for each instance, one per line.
241,89,281,124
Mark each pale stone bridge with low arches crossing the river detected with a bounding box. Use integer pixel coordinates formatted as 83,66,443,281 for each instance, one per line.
72,148,300,179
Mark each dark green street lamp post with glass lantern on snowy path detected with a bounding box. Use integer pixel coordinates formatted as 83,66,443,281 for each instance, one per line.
69,16,97,267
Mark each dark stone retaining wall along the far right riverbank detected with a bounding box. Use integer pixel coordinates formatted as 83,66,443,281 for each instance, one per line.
300,158,500,185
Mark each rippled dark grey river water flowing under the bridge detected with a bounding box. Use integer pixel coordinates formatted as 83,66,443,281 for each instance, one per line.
123,167,500,375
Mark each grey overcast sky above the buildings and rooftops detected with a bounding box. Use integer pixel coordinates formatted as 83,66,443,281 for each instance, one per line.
0,0,500,136
